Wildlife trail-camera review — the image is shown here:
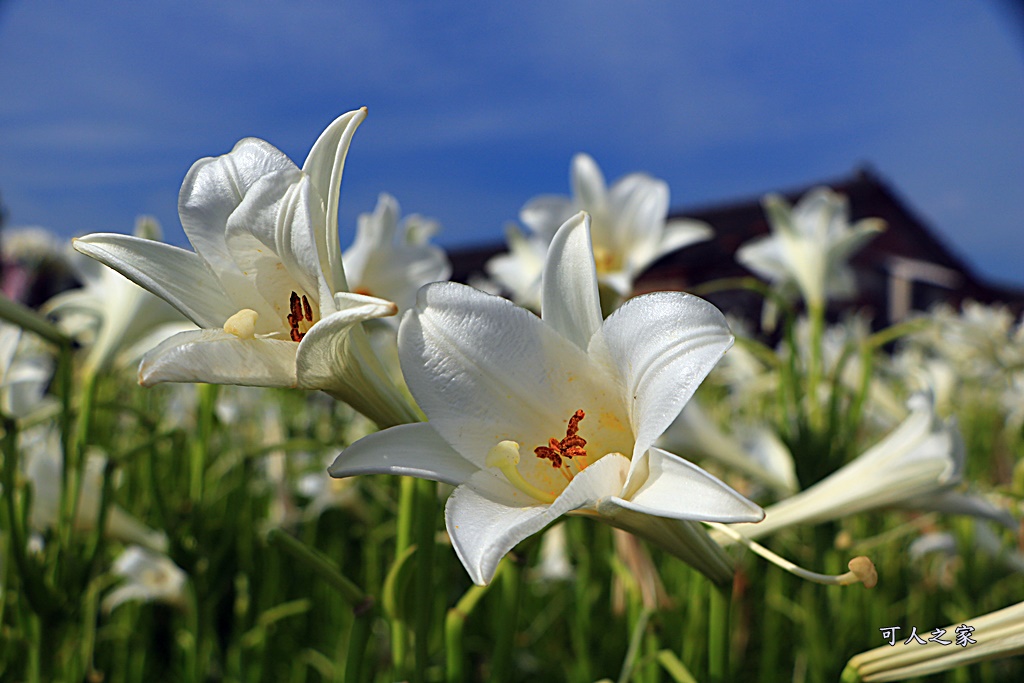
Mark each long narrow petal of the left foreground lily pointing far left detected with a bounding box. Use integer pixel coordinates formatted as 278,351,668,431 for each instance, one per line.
73,232,239,328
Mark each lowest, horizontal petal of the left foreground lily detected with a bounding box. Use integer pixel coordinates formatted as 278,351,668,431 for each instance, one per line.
138,330,299,387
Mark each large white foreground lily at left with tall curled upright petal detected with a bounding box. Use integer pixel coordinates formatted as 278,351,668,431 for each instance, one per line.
75,109,417,424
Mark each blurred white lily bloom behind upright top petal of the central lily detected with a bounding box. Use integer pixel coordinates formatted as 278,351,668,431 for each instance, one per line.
487,154,712,305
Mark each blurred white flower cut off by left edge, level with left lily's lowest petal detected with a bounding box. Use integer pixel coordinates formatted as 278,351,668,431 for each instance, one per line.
0,321,53,418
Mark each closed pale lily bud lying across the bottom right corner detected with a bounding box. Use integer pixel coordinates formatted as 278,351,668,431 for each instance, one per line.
843,602,1024,683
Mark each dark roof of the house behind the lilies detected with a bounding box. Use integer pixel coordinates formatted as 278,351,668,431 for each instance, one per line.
451,168,1024,325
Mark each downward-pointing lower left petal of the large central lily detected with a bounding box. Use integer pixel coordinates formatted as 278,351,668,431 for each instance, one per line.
444,455,629,586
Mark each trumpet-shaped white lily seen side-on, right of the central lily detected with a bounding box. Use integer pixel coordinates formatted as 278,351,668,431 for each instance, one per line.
723,394,965,543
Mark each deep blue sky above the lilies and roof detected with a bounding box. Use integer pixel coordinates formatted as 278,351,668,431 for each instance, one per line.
0,0,1024,284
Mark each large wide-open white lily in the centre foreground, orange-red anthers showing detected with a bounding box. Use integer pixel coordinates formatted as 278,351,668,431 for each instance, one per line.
330,213,762,584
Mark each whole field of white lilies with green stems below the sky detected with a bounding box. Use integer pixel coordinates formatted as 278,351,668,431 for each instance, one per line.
0,110,1024,683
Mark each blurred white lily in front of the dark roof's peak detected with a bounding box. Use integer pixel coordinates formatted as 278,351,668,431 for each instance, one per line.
736,187,885,307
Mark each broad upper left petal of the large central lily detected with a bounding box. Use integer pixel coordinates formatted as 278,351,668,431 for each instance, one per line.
398,283,610,467
